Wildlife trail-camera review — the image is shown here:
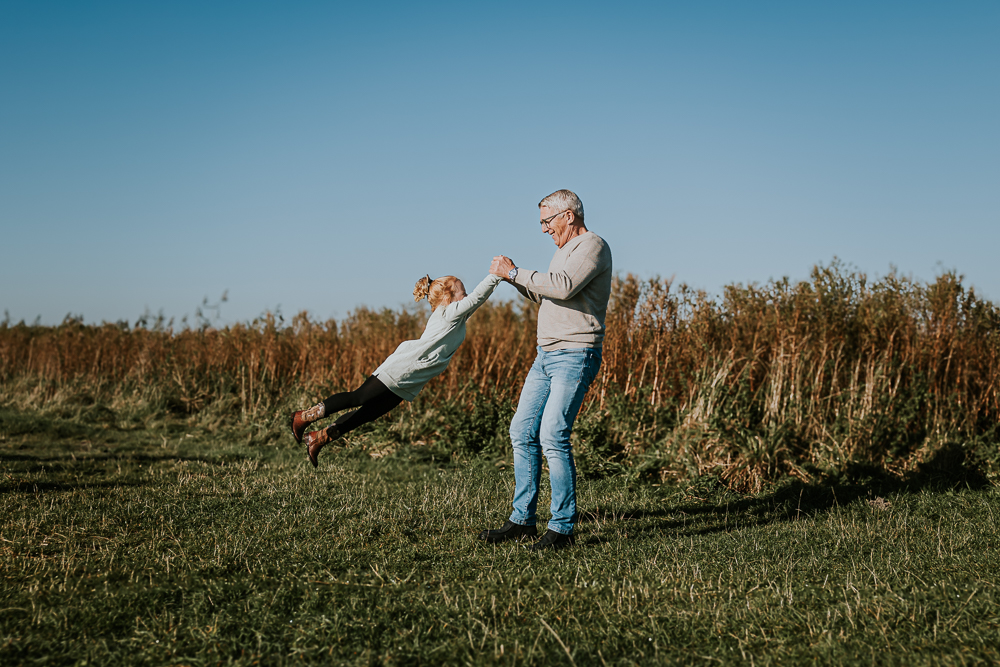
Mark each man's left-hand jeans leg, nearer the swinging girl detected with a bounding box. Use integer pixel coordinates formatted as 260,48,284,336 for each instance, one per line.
510,350,549,526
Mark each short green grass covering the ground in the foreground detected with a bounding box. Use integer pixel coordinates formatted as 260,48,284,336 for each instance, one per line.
0,410,1000,665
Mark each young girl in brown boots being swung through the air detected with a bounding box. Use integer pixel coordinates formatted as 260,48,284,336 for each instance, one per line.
292,275,500,467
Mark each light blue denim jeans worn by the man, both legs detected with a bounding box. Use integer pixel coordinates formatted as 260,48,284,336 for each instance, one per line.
510,348,601,535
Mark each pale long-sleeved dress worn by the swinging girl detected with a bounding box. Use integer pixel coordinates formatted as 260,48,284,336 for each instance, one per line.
373,274,500,401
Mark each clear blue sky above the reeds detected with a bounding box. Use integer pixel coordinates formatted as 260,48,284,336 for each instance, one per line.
0,0,1000,323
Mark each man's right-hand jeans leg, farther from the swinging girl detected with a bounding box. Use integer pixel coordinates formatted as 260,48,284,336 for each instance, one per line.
539,349,601,535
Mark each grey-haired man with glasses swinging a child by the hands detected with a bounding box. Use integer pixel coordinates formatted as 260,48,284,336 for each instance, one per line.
479,190,611,550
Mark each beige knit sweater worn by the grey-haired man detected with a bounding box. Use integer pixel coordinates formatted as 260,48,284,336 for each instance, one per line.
514,231,611,352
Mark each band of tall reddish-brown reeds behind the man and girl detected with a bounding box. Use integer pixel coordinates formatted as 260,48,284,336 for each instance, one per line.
0,260,1000,492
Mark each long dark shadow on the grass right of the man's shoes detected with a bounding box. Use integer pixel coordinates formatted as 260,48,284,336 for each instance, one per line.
580,443,991,544
